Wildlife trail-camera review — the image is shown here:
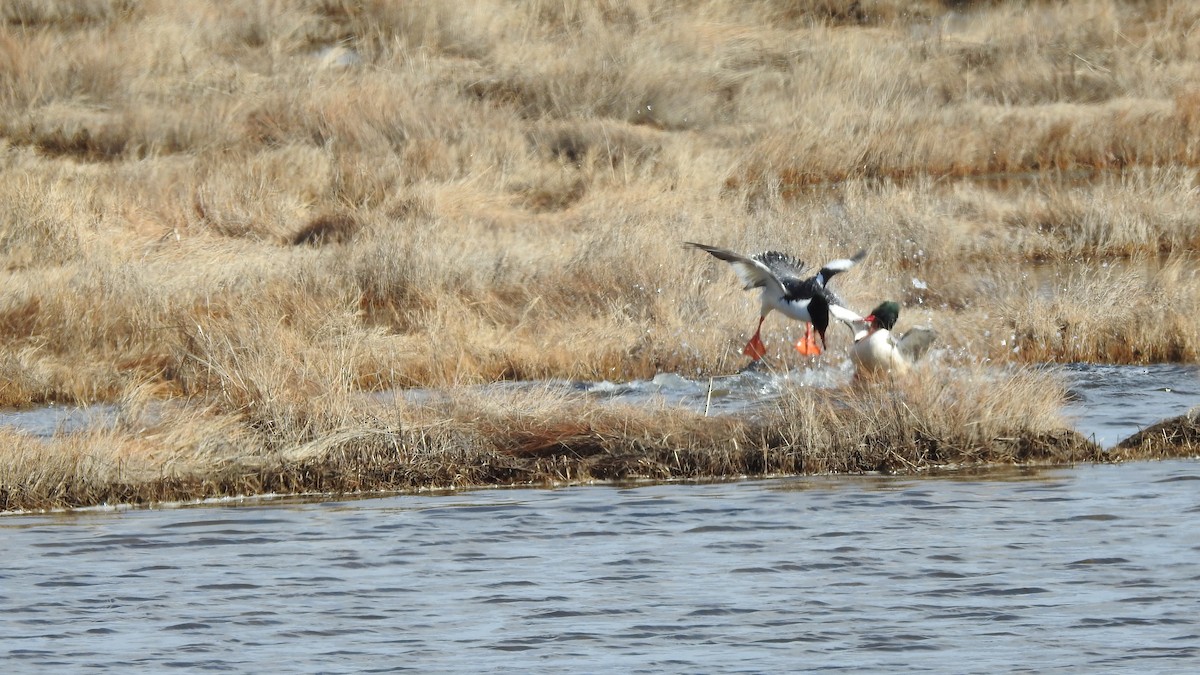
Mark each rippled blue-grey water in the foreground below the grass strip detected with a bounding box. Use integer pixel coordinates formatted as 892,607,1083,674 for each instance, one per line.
0,461,1200,673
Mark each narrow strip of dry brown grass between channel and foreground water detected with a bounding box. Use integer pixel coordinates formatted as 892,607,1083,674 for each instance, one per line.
0,368,1123,510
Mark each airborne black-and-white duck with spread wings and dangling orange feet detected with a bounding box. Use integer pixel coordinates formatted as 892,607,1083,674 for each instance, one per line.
684,241,866,360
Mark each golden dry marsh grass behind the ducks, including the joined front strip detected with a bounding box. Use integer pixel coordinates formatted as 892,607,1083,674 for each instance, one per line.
0,0,1200,508
